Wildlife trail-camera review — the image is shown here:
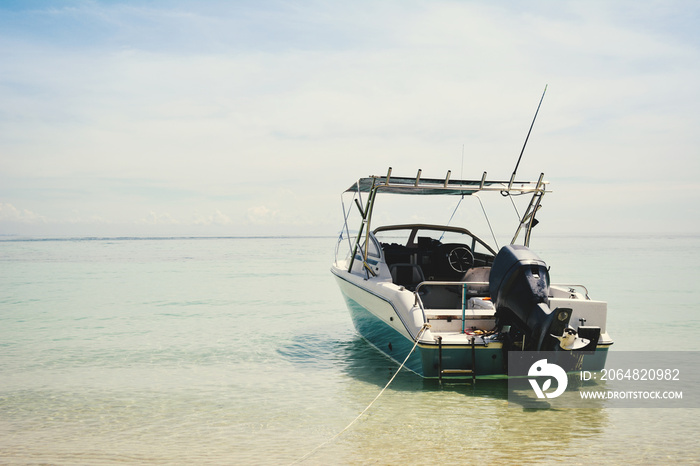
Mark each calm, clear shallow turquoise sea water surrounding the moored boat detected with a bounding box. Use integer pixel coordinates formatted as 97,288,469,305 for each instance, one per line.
0,236,700,464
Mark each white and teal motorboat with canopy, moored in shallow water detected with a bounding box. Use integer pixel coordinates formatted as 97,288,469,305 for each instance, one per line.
331,169,613,380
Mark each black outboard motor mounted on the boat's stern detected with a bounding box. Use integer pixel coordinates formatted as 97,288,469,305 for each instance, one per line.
489,245,571,351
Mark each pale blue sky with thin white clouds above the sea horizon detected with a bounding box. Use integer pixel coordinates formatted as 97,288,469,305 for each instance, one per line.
0,0,700,237
